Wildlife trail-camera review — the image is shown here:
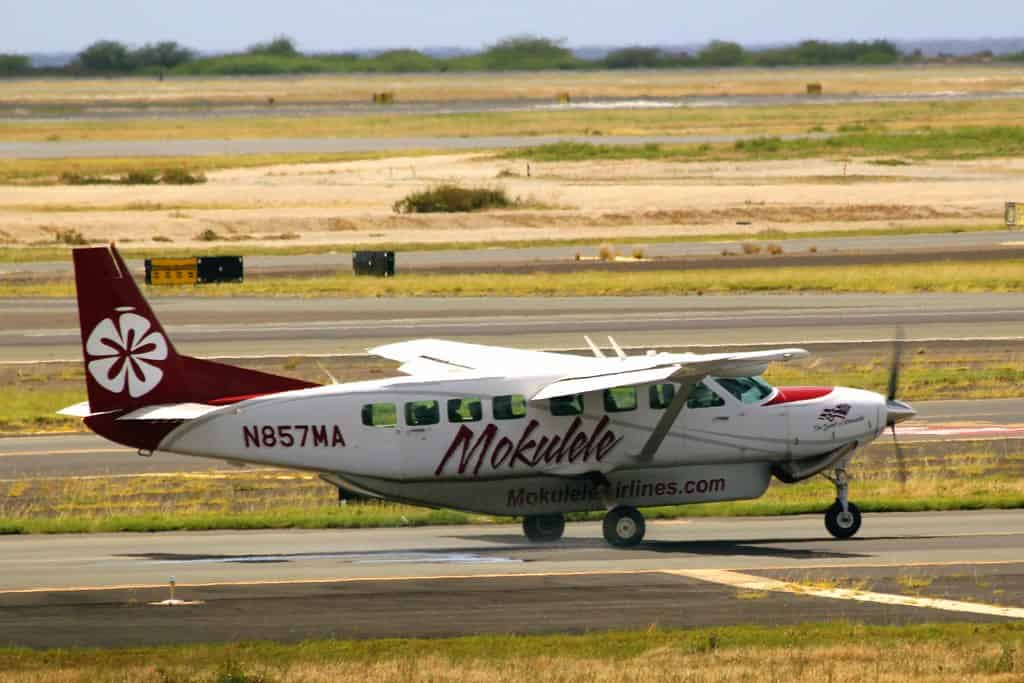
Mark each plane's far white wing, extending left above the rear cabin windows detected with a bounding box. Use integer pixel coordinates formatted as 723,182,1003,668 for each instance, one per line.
369,339,601,376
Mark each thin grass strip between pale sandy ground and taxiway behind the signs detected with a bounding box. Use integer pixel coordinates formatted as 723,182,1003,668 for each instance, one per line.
0,224,1004,265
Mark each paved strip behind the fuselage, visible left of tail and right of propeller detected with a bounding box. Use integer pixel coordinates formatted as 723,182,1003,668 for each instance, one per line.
0,398,1024,480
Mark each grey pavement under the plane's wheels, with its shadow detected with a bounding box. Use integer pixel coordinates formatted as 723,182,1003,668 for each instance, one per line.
0,511,1024,647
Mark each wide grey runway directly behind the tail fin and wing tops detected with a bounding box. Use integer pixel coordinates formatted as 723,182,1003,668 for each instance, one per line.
0,293,1024,362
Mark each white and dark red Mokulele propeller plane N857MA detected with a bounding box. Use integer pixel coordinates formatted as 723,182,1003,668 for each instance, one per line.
61,245,913,547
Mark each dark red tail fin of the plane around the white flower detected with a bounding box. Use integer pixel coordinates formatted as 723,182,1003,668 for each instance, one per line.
74,245,315,413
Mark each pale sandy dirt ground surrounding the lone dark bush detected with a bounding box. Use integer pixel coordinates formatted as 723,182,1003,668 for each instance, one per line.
0,154,1011,248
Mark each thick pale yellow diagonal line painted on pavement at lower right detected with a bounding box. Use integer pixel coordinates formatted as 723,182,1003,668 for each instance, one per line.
664,569,1024,618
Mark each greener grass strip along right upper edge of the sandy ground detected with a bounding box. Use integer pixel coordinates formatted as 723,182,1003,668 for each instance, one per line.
501,126,1024,165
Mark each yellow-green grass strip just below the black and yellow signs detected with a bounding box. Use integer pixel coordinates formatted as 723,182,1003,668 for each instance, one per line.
0,260,1024,297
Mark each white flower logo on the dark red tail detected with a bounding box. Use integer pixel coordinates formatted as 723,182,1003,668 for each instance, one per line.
85,313,167,398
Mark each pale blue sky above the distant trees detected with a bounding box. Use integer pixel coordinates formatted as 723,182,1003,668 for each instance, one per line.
0,0,1024,53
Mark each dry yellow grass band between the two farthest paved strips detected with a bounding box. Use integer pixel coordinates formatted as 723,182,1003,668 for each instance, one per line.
6,99,1024,142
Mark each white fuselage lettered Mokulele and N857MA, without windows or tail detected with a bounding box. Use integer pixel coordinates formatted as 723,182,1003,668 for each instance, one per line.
160,374,886,515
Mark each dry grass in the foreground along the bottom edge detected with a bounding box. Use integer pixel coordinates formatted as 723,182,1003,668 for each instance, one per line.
0,622,1024,683
